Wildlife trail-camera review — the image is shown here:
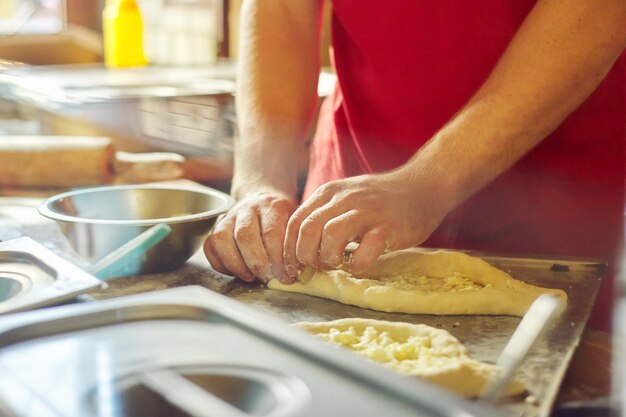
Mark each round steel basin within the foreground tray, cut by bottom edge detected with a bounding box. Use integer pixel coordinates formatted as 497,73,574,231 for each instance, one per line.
90,365,309,417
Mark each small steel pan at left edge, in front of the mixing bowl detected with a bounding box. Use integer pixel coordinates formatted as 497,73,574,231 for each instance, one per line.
0,237,103,314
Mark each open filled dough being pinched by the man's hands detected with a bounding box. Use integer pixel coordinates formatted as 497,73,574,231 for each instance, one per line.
268,248,567,317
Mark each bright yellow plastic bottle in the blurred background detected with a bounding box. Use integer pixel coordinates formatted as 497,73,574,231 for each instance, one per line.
102,0,147,68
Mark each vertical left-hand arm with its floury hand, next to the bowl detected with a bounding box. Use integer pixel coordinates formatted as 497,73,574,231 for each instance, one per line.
204,0,323,282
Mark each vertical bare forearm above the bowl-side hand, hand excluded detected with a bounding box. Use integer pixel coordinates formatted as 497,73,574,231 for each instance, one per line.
232,0,321,198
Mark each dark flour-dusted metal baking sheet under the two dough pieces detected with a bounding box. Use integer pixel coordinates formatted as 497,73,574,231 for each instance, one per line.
227,253,606,417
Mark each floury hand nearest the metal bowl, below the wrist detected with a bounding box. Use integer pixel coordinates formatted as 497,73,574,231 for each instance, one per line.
204,192,297,283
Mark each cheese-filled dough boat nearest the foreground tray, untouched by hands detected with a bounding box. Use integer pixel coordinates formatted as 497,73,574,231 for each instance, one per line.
296,318,526,397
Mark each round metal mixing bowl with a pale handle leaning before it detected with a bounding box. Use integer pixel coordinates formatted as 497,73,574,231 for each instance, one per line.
39,184,233,275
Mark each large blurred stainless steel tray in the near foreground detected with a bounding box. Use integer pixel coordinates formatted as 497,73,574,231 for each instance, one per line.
0,286,491,417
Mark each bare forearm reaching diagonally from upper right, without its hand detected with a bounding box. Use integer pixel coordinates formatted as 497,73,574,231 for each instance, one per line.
399,0,626,211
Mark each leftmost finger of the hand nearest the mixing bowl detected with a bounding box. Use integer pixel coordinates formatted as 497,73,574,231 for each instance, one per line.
205,216,254,282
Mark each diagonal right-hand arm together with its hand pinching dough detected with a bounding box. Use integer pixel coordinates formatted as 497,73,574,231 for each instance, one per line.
285,0,626,277
